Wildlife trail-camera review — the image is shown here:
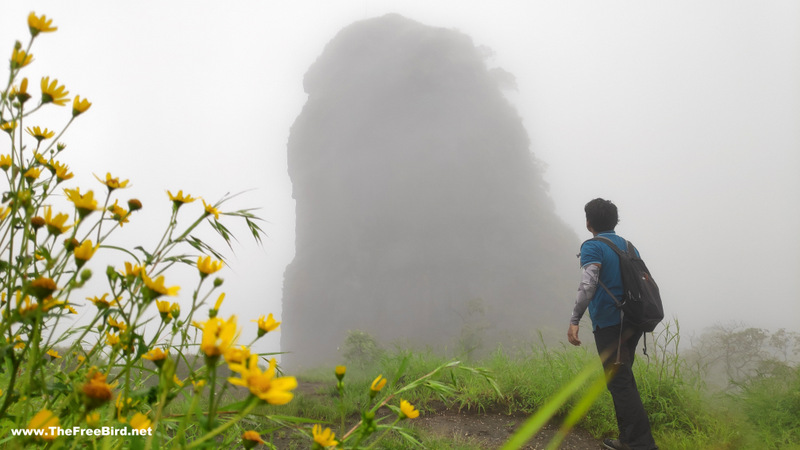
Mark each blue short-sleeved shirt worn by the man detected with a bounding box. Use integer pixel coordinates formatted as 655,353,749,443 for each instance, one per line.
581,231,628,329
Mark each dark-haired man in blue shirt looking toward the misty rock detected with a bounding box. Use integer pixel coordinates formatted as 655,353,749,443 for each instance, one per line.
567,198,658,450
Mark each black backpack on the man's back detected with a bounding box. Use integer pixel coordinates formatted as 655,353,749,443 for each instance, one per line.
589,236,664,333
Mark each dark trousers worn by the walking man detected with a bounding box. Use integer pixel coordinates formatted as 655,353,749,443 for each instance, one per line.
594,325,658,450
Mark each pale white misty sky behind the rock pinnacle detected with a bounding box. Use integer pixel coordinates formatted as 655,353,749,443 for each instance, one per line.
0,0,800,351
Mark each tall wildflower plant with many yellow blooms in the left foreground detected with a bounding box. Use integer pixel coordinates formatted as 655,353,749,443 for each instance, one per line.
0,12,496,449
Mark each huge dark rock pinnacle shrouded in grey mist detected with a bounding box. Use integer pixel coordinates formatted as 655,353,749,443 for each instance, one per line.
281,15,577,367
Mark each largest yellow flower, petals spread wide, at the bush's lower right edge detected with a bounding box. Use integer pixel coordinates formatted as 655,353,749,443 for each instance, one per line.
228,355,297,405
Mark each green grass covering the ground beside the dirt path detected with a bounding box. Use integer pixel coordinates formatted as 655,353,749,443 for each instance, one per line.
152,330,800,450
